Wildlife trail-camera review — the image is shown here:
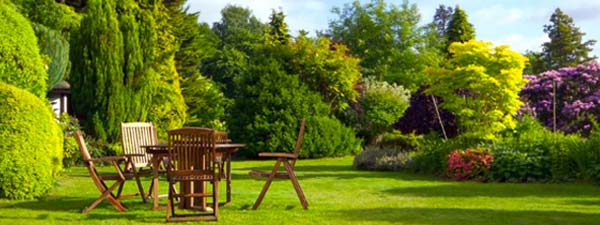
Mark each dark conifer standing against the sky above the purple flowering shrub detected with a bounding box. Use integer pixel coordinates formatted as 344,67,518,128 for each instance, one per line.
542,8,596,70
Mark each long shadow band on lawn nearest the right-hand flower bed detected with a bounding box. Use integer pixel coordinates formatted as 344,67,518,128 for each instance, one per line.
385,182,600,199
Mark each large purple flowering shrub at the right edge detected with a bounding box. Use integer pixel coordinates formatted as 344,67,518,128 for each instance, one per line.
520,61,600,133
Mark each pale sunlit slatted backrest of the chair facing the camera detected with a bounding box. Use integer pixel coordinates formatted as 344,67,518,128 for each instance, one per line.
121,122,158,167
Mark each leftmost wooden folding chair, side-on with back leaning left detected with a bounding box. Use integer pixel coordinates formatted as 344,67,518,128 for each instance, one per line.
75,131,143,213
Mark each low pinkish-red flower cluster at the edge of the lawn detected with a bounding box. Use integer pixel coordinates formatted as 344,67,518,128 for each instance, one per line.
447,147,494,180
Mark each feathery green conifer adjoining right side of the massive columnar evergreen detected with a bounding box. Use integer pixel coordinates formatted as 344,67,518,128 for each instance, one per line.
164,0,229,130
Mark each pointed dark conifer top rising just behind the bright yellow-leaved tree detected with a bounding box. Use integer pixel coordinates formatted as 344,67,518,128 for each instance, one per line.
445,5,475,51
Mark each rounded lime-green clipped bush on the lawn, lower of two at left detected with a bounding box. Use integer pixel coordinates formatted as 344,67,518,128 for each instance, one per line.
0,82,63,199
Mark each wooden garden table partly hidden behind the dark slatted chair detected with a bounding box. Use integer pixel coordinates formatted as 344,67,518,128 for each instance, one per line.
141,143,246,210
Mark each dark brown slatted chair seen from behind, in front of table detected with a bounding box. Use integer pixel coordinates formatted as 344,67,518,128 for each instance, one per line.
166,128,219,222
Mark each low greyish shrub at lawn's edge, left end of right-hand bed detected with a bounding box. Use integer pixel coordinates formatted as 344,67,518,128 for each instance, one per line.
353,146,416,171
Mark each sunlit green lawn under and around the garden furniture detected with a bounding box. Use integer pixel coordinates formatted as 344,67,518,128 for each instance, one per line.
0,157,600,225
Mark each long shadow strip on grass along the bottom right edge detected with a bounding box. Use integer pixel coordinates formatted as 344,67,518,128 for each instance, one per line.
333,208,600,225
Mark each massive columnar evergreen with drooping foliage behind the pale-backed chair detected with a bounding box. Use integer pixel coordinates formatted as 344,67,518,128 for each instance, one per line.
70,0,185,142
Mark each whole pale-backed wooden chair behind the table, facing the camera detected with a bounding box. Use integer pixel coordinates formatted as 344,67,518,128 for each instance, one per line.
121,122,158,203
